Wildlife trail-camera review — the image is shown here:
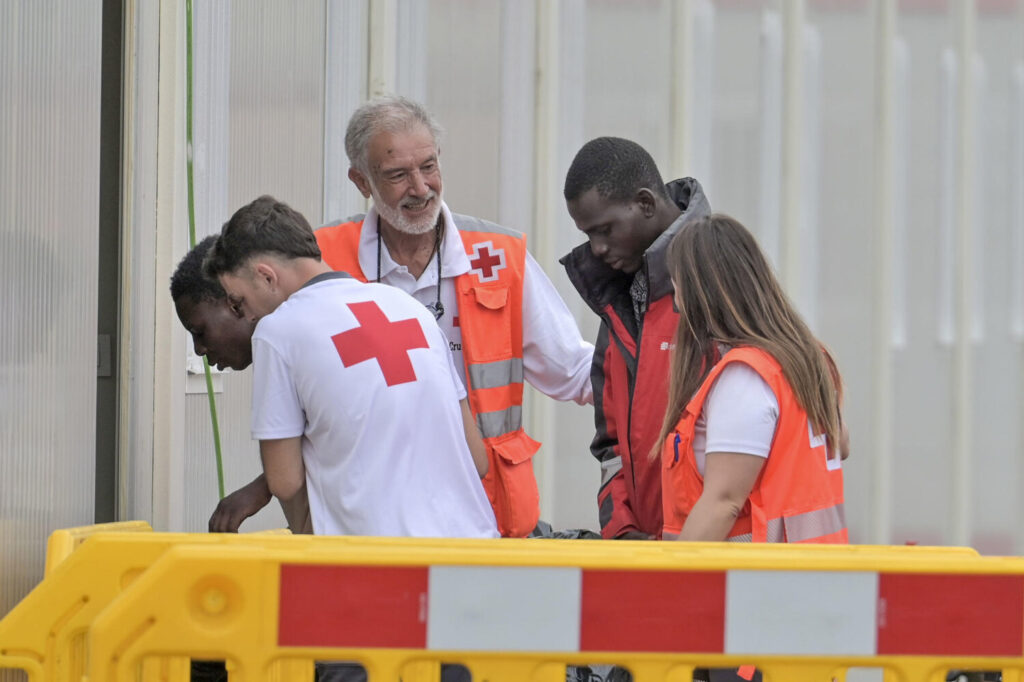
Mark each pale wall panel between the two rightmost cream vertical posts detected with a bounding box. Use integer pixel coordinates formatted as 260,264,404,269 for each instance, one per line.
892,11,954,544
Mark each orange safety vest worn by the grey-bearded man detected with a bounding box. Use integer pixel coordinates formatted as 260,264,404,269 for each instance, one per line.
315,214,541,538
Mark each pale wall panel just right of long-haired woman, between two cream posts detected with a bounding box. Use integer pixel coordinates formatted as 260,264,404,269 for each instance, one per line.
802,3,874,542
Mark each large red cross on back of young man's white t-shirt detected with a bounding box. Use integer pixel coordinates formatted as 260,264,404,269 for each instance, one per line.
331,301,428,386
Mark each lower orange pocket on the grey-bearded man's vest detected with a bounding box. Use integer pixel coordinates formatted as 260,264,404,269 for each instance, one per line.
483,429,541,538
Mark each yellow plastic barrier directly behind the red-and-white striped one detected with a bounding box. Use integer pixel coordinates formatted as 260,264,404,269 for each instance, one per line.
0,523,999,682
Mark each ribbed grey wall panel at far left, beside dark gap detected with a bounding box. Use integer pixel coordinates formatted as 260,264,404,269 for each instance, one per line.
0,0,102,614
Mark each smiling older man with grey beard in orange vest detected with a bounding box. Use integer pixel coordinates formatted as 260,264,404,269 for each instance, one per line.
315,96,594,538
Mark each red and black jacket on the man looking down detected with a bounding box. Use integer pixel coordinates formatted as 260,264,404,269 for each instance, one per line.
560,177,711,538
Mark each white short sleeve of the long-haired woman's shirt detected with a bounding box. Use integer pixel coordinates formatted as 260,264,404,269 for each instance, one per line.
693,363,778,476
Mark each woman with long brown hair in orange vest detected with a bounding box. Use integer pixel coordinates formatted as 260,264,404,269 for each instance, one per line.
652,214,848,543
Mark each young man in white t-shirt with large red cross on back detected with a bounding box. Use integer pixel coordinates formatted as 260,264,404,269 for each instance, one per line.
205,192,498,538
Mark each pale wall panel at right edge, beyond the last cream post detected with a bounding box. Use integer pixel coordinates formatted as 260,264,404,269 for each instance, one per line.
969,3,1024,554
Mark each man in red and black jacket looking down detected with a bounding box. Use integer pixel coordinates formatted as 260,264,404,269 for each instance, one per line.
561,137,711,539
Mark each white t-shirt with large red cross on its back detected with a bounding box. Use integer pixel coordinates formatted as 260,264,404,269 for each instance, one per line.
252,272,498,538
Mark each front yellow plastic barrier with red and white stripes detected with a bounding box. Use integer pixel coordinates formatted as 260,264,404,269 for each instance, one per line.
36,537,1003,682
